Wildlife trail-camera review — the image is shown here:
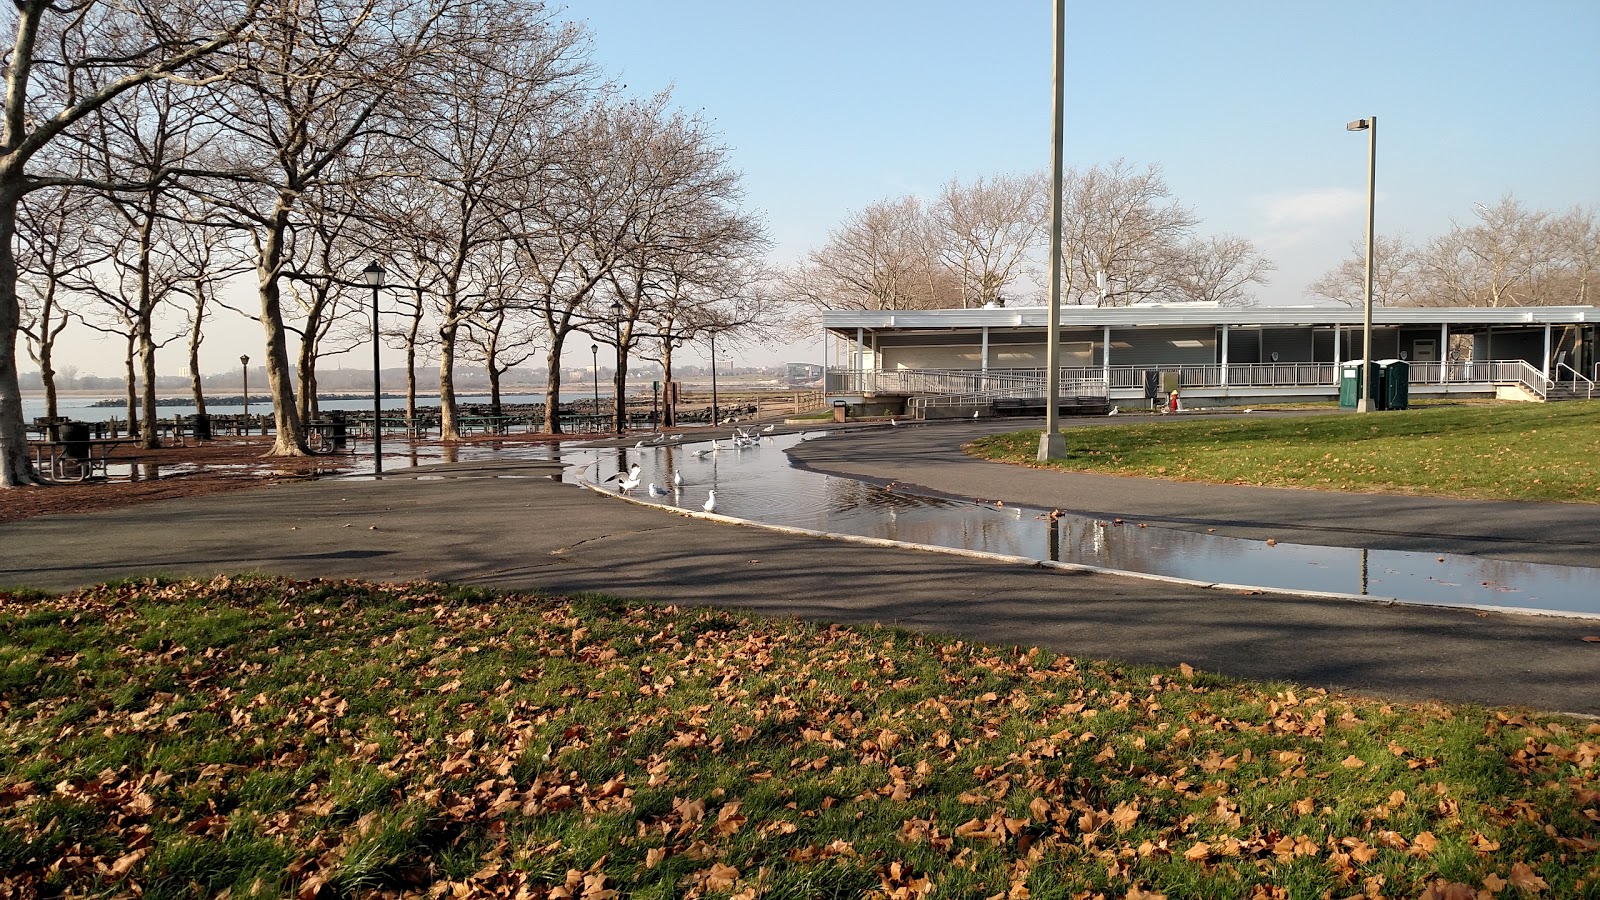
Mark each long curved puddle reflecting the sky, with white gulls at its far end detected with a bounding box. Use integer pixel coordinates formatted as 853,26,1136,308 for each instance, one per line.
563,436,1600,613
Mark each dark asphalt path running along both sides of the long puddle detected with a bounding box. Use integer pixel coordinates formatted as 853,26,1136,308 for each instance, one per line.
9,423,1600,716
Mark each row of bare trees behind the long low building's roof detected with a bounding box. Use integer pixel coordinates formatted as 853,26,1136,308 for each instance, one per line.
787,160,1600,312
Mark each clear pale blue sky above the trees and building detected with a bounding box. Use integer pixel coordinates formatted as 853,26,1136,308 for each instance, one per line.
34,0,1600,375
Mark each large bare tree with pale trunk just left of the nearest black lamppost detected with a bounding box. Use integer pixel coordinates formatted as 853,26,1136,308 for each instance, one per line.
195,0,470,456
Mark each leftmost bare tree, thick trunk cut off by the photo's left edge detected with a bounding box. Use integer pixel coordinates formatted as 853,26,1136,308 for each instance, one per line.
0,0,261,487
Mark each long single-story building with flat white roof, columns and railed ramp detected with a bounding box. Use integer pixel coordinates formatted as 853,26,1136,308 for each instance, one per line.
822,304,1600,418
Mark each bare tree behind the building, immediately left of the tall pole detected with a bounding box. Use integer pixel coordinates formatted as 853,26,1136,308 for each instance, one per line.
933,173,1045,307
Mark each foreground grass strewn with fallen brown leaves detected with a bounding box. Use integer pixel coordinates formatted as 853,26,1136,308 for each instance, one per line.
0,578,1600,900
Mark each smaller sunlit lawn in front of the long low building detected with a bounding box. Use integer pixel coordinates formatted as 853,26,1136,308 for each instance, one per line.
968,402,1600,503
